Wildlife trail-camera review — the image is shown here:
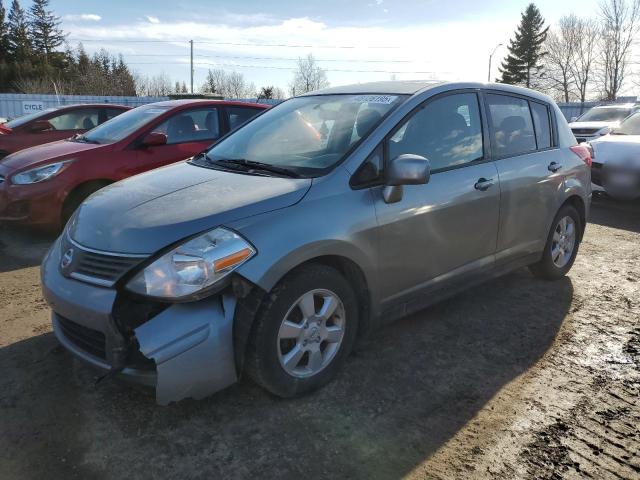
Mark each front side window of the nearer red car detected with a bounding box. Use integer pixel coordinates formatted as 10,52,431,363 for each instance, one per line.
153,107,220,145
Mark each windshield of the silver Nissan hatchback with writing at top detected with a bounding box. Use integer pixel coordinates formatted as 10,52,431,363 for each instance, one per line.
202,95,404,176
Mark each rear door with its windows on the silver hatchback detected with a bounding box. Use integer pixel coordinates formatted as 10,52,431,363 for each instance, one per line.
485,92,563,263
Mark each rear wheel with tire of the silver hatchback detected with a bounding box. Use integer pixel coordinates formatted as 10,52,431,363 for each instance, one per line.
529,205,582,280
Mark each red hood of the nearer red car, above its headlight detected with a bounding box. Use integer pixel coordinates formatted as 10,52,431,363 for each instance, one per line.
0,140,108,171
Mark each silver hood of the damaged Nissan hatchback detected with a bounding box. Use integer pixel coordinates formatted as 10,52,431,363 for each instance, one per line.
69,162,311,254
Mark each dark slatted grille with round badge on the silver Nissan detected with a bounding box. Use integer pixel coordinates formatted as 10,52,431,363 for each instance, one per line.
61,234,145,287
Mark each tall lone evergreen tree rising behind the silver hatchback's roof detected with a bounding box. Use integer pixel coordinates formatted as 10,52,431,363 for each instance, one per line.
499,3,549,87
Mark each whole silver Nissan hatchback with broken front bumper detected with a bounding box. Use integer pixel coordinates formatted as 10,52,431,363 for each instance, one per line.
42,82,591,404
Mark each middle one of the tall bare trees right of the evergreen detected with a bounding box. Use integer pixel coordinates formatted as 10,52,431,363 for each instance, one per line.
569,18,601,103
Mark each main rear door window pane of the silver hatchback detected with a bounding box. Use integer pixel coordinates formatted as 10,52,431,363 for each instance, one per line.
487,94,536,157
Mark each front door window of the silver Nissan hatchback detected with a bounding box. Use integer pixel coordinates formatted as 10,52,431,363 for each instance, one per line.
389,93,484,171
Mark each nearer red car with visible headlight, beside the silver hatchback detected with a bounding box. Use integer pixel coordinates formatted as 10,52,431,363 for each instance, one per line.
0,100,267,229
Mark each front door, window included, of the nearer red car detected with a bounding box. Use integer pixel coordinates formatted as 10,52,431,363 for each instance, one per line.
136,106,222,171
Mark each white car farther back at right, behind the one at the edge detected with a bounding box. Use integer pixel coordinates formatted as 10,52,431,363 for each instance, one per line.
569,103,640,143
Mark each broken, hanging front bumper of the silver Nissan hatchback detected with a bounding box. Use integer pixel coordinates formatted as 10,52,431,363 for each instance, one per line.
41,240,237,405
